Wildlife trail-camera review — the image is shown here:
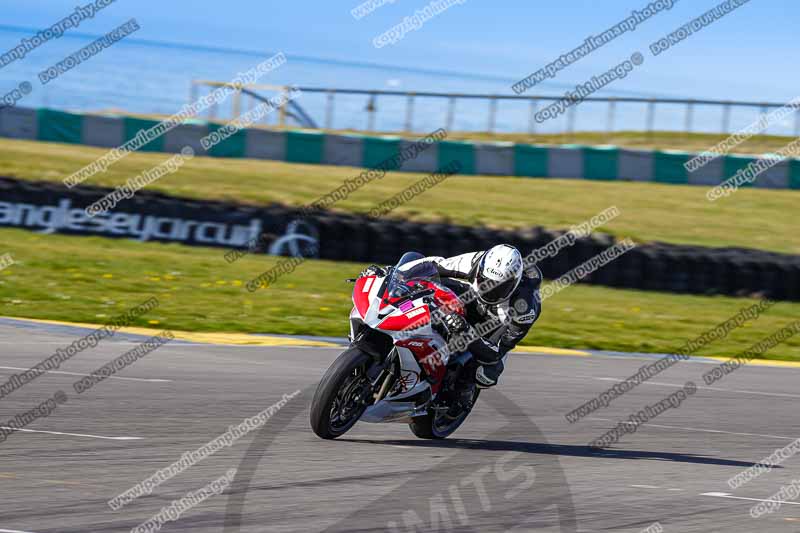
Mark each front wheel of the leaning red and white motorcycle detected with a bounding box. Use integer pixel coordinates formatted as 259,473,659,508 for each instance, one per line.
311,347,372,439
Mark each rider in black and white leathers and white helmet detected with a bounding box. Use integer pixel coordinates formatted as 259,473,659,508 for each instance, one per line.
362,244,542,388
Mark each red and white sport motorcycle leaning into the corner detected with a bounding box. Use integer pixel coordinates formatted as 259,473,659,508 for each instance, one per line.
311,252,480,439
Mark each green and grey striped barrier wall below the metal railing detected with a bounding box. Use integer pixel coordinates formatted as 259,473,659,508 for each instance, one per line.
0,107,800,190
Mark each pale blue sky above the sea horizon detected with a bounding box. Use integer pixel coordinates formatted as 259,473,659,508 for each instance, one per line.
2,0,800,101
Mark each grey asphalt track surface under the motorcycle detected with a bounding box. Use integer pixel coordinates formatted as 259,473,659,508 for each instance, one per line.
0,318,800,533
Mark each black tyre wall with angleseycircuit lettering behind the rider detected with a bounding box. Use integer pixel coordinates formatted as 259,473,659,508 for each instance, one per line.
0,178,800,301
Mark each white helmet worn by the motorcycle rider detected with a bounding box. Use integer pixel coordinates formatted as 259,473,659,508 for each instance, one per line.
472,244,523,305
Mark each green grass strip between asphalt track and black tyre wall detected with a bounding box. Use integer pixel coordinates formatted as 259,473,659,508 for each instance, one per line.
0,229,800,361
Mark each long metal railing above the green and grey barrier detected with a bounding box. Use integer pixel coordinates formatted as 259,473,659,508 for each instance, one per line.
191,80,800,136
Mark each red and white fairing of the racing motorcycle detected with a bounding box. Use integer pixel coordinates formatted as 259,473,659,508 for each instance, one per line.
350,276,464,422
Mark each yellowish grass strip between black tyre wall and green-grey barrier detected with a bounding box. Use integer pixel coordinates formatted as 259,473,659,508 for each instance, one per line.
0,139,800,254
